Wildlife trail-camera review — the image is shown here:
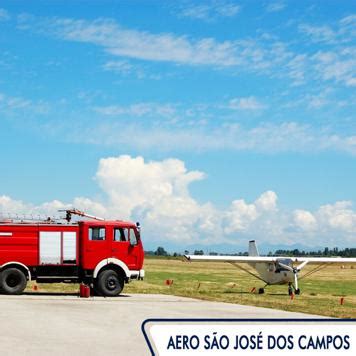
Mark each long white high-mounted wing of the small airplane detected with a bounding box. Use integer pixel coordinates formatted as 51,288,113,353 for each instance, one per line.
184,255,356,264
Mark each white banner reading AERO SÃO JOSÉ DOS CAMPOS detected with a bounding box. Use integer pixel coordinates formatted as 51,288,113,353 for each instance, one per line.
143,320,356,356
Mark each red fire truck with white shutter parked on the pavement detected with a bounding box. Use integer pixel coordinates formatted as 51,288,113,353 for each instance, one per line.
0,209,144,296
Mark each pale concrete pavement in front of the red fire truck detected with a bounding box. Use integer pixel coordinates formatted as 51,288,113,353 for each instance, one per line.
0,294,322,356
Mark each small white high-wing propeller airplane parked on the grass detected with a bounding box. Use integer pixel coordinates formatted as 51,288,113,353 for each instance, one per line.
184,240,356,295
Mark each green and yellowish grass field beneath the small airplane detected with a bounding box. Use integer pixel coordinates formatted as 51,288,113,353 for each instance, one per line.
28,258,356,318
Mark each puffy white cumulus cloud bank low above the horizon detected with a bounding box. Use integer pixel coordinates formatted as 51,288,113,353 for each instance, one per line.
0,155,356,250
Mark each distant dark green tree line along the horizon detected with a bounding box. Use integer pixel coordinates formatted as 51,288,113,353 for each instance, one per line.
145,246,356,257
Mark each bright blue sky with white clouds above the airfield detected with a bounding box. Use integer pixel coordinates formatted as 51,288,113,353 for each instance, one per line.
0,0,356,248
